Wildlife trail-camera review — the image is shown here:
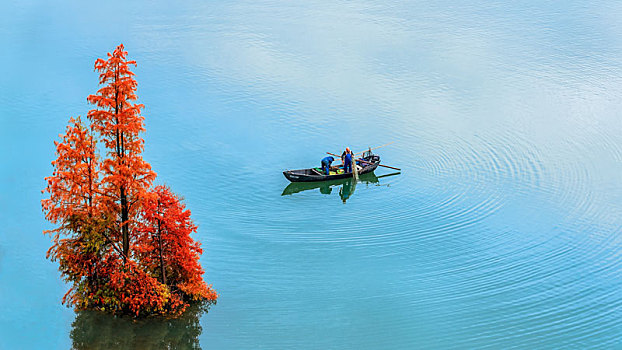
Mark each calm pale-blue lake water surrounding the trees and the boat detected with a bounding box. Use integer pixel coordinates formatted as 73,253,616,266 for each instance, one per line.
0,0,622,349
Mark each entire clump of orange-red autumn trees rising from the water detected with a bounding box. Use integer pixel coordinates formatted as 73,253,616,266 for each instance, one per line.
42,45,217,316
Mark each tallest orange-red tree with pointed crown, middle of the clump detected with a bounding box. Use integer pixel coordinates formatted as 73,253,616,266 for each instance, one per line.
87,45,156,261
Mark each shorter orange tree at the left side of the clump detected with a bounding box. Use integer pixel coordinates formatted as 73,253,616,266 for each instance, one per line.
42,117,107,302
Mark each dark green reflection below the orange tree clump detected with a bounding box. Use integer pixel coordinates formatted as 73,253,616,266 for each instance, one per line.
71,303,210,350
